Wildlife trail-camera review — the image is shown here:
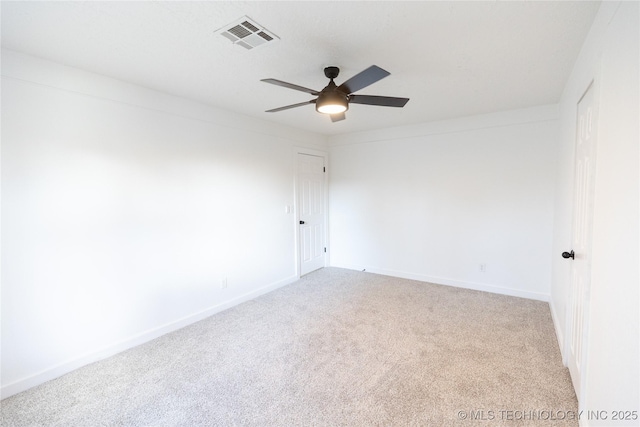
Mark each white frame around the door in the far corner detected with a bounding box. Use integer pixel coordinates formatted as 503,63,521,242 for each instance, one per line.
293,147,331,279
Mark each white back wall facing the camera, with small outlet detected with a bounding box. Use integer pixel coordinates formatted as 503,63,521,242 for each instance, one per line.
329,106,558,300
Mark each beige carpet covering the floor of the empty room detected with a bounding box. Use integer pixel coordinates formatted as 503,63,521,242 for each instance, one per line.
0,268,578,426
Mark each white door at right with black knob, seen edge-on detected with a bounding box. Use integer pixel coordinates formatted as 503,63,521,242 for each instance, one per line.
563,84,597,401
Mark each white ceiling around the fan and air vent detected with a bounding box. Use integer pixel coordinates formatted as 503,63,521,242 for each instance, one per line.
1,1,599,135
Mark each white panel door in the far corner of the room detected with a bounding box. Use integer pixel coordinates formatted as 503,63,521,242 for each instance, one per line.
298,153,326,275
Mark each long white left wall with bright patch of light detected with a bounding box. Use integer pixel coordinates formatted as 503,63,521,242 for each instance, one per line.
2,51,326,396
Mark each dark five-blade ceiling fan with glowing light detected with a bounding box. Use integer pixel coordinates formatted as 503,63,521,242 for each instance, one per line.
261,65,409,122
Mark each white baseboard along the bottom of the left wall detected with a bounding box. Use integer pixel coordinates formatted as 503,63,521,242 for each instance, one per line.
0,276,298,399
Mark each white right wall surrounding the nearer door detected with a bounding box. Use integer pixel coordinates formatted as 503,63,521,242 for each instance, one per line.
551,2,640,425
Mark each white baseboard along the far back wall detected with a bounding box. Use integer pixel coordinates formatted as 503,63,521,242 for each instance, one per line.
332,265,549,302
